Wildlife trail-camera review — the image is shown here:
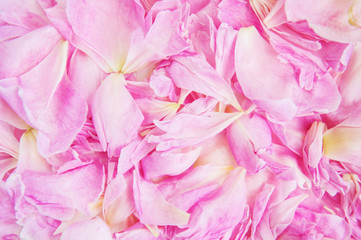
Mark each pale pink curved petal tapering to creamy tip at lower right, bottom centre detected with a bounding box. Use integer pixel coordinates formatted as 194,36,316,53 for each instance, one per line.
133,171,189,226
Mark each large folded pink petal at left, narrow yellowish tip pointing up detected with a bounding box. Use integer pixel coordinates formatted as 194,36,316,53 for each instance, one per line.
19,42,87,156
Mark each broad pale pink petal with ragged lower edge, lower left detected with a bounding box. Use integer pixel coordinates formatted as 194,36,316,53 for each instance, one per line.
21,163,104,220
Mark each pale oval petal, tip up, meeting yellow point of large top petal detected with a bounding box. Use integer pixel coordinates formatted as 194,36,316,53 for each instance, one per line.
92,74,143,156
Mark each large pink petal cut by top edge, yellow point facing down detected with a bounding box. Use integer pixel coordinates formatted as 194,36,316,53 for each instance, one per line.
66,0,144,72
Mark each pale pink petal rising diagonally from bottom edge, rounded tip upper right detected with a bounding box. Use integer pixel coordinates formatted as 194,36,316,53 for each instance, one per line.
177,168,246,239
